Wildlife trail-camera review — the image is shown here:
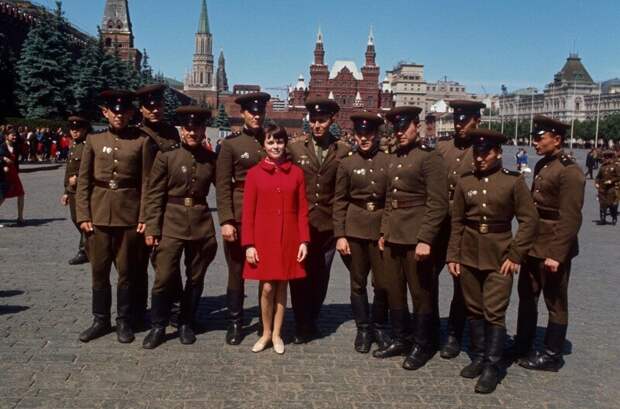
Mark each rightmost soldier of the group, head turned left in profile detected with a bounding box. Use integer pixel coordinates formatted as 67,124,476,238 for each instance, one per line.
514,115,585,371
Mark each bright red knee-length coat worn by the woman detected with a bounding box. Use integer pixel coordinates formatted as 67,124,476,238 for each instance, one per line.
241,159,310,280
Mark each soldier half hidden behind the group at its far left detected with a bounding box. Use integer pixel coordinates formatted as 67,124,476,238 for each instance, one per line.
60,116,92,265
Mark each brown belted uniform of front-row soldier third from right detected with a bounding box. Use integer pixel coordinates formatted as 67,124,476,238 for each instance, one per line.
381,144,448,351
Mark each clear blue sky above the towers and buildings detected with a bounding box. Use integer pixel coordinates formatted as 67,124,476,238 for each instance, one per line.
37,0,620,92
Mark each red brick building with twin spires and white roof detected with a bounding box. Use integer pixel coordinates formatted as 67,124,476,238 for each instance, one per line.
289,28,392,129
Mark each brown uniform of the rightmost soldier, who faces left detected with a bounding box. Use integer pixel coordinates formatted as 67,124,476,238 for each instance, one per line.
516,151,585,354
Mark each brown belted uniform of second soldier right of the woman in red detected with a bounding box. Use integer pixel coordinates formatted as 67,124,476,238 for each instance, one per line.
333,147,390,342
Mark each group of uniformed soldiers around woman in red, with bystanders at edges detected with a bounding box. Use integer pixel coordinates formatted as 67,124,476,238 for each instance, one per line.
0,81,620,393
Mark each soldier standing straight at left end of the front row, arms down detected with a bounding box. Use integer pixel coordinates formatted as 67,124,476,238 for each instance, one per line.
76,91,153,343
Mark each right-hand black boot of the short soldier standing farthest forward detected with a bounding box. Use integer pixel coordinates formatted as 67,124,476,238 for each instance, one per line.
475,324,506,394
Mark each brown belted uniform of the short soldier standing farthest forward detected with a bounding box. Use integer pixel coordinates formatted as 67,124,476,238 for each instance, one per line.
447,164,538,326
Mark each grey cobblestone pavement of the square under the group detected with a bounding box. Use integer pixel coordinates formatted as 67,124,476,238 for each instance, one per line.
0,149,620,409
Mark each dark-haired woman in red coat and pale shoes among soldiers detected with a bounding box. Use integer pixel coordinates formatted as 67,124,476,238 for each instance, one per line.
241,126,310,354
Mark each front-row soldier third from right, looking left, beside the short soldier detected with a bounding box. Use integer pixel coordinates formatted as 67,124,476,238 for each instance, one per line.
373,106,448,370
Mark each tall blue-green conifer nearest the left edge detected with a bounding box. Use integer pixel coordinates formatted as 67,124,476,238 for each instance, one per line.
16,1,72,118
